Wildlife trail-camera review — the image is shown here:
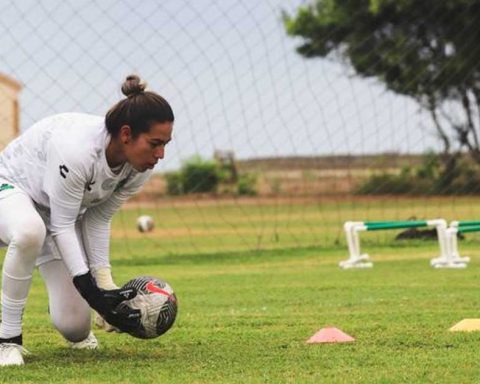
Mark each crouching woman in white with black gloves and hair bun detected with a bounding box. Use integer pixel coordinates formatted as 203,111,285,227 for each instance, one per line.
0,75,174,365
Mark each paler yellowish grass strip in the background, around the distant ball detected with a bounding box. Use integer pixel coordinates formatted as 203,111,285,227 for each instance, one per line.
117,197,480,255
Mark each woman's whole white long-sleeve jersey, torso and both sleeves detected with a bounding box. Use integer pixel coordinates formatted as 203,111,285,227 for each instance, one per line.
0,113,151,276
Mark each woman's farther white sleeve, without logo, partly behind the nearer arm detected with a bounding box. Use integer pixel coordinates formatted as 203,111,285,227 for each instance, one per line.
82,168,151,270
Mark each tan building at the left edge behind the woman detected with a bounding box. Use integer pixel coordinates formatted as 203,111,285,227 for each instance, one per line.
0,73,22,149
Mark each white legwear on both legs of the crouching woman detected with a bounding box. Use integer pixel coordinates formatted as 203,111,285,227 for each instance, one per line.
0,180,91,342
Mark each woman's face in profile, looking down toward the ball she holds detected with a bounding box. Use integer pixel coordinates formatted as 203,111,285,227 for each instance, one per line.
121,122,173,172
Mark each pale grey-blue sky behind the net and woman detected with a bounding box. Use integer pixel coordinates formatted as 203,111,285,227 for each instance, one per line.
0,0,439,170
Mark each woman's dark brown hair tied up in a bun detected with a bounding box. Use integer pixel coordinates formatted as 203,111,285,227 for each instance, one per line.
105,75,175,138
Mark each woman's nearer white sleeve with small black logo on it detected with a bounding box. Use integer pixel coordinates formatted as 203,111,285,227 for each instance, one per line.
43,141,89,276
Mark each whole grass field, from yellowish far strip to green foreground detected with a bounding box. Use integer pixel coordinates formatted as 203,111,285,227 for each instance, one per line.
0,200,480,383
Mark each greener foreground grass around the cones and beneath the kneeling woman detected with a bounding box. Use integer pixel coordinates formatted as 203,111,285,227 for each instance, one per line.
4,245,480,383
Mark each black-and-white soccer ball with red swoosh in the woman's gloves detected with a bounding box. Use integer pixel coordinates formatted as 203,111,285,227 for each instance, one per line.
120,276,178,339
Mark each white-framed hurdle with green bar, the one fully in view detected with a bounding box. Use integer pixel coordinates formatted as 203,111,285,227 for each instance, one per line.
339,219,464,269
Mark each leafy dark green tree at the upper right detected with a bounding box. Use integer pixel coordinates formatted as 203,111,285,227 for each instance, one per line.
283,0,480,185
